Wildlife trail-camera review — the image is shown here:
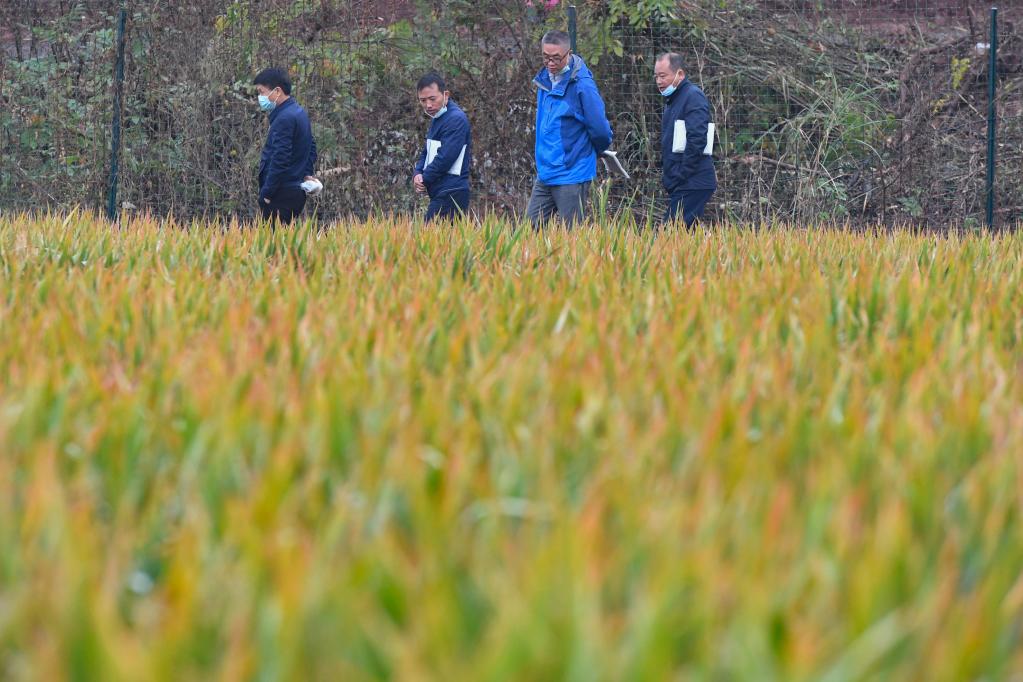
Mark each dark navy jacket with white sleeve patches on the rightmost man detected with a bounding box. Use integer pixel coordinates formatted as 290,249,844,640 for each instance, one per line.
661,78,717,195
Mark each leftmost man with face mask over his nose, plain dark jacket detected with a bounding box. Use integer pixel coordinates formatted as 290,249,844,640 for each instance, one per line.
253,69,316,224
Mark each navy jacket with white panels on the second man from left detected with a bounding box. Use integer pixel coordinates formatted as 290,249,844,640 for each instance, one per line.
415,98,473,198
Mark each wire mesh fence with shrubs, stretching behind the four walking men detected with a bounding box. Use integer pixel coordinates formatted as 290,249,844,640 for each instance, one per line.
0,0,1023,226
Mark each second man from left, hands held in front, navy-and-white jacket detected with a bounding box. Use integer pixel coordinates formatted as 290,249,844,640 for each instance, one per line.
412,74,473,223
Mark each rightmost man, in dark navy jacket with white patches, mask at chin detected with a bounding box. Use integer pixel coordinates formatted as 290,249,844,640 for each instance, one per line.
654,52,717,227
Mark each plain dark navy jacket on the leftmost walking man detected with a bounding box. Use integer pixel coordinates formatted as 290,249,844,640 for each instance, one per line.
259,97,316,201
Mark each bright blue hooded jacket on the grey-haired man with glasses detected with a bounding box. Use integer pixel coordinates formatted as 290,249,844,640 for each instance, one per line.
533,54,612,185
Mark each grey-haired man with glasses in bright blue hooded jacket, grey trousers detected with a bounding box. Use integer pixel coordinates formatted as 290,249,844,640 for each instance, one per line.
526,31,611,227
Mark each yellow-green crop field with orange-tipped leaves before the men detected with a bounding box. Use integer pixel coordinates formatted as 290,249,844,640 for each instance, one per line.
0,212,1023,682
